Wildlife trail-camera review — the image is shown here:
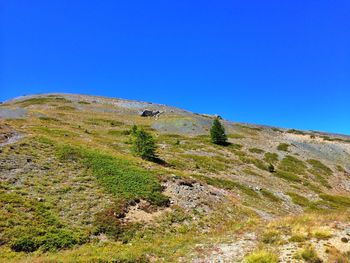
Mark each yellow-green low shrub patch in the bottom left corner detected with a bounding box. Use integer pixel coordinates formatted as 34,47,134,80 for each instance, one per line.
0,187,88,252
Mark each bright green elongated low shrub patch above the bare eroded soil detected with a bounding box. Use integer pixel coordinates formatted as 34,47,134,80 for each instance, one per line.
58,145,168,205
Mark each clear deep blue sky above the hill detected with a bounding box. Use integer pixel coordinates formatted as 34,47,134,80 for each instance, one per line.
0,0,350,134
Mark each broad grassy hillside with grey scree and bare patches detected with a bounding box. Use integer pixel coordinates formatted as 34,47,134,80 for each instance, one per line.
0,94,350,262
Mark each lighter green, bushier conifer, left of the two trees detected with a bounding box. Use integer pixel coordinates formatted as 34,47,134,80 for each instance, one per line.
131,128,157,160
